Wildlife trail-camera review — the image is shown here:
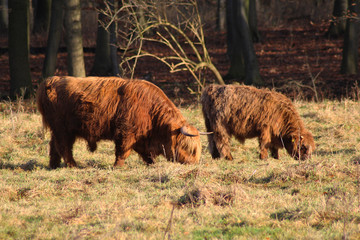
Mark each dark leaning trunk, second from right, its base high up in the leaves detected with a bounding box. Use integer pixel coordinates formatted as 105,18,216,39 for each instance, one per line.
326,0,348,38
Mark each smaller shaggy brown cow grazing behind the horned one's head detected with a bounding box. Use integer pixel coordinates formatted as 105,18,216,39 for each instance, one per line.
201,85,315,160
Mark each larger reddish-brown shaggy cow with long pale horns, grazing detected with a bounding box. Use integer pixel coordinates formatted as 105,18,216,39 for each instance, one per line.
37,77,201,168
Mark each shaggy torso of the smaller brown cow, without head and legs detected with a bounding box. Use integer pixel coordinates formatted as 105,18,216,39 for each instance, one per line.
202,85,302,138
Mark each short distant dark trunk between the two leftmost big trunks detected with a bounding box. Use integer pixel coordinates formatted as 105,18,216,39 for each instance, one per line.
33,0,51,33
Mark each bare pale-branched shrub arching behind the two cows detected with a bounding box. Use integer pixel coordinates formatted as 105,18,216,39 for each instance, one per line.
103,0,224,92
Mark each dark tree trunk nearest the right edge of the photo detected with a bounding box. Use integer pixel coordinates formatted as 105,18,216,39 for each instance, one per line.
341,0,360,74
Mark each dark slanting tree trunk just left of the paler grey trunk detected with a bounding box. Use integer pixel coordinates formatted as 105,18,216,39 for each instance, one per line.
42,0,64,79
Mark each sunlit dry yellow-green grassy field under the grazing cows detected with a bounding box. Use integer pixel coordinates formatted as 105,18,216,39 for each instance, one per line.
0,96,360,239
